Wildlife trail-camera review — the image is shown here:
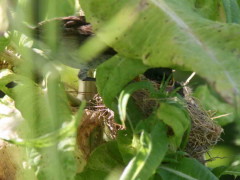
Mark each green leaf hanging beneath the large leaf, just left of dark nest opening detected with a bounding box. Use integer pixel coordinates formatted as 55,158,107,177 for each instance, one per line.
96,56,148,107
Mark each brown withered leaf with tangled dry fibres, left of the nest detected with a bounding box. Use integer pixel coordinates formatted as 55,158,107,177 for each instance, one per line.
77,94,122,159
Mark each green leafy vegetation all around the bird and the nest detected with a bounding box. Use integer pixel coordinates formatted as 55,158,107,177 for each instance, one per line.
0,0,240,180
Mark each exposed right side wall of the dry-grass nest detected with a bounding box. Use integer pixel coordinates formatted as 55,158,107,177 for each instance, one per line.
184,87,223,163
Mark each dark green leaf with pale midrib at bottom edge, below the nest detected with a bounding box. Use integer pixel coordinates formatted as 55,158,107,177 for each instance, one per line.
158,158,218,180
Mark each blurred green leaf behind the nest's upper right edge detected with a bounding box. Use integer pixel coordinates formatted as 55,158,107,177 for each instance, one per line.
194,85,234,126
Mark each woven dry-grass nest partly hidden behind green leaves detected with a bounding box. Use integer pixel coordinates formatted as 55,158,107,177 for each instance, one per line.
133,82,223,163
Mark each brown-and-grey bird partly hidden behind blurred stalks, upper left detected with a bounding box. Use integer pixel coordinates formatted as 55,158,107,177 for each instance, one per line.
33,16,117,81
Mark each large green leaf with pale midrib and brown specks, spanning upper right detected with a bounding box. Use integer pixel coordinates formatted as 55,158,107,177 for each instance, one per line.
81,0,240,103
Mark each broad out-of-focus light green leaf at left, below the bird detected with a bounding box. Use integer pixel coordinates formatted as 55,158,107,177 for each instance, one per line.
13,75,72,138
